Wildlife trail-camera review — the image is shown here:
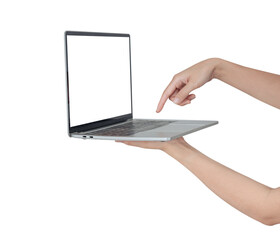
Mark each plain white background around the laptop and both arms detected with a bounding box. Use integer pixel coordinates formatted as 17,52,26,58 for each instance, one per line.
0,0,280,240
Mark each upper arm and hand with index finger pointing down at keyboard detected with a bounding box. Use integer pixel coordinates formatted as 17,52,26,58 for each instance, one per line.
157,58,280,112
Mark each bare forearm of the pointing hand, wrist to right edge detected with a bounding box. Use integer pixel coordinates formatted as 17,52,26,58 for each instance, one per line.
213,59,280,109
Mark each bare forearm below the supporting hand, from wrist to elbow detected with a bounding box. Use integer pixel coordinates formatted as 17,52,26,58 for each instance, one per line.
164,146,272,224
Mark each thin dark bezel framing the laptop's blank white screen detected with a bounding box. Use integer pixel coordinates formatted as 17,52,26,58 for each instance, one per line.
64,31,133,136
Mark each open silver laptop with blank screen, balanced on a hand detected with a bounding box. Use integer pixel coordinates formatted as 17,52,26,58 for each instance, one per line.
65,31,218,141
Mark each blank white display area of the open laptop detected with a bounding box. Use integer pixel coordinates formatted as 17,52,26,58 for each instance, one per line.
67,35,131,127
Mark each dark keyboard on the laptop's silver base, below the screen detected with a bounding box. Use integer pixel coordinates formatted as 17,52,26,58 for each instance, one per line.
86,119,174,136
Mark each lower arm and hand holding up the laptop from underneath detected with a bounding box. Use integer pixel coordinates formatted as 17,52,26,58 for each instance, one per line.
120,138,280,225
